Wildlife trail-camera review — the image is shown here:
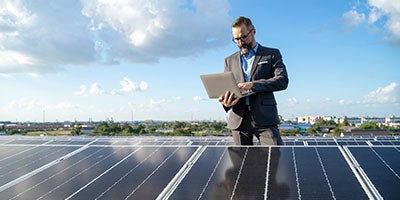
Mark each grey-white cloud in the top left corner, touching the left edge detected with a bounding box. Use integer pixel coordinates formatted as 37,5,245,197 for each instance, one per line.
0,0,96,74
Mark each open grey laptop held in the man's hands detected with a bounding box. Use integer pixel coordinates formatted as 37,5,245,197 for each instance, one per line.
200,72,253,99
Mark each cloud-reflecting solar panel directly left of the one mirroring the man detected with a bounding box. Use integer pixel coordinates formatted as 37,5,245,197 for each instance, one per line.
0,147,196,199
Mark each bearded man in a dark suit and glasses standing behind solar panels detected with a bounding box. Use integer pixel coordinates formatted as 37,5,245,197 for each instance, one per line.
218,17,289,145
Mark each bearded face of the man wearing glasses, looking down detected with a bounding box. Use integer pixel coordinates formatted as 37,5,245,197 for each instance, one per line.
232,24,255,54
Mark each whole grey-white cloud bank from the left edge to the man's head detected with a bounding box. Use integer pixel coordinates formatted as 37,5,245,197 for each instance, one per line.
0,0,231,74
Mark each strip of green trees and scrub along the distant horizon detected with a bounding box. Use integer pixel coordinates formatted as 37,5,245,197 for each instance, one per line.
0,117,399,136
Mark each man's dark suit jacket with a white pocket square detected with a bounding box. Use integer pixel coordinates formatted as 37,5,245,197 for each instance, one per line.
224,45,289,130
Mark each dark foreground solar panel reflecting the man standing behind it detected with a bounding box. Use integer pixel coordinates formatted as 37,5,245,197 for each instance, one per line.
165,147,368,199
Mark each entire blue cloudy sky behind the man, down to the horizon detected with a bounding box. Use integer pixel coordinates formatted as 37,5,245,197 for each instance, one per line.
0,0,400,122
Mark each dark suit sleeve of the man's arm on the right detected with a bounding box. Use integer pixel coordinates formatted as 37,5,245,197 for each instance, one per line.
253,49,289,92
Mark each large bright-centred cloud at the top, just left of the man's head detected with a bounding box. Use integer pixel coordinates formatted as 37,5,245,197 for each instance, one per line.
82,0,230,63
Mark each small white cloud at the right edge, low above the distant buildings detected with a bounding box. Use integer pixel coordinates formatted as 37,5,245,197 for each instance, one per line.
362,83,400,104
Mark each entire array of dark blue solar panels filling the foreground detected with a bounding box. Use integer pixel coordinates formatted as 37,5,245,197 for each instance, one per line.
0,136,400,199
